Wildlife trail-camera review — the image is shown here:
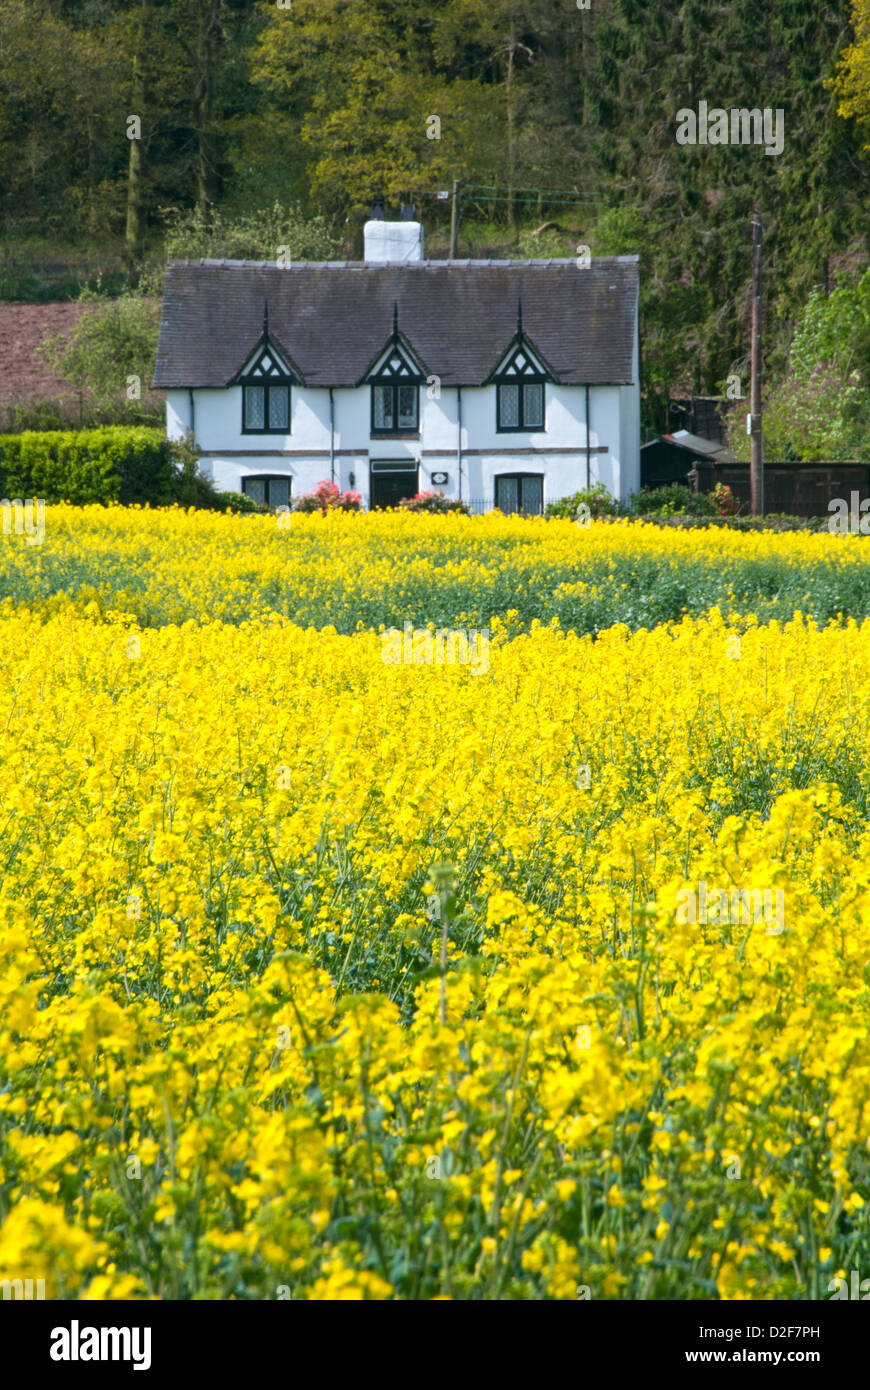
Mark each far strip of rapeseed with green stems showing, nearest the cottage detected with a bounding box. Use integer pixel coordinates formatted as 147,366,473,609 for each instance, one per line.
6,506,870,632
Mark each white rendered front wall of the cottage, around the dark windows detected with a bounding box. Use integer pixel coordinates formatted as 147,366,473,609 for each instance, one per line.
167,378,641,505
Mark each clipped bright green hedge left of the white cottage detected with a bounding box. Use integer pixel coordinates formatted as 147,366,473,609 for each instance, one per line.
0,425,179,506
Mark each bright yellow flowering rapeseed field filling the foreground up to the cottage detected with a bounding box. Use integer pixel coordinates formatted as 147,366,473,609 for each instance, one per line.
0,509,870,1300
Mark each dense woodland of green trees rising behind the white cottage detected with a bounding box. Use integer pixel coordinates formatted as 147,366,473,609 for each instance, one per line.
0,0,870,439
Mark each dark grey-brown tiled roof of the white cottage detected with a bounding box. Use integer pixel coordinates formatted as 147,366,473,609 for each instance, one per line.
154,256,638,389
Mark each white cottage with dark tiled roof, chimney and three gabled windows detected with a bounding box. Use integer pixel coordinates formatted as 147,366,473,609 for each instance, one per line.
154,222,641,514
